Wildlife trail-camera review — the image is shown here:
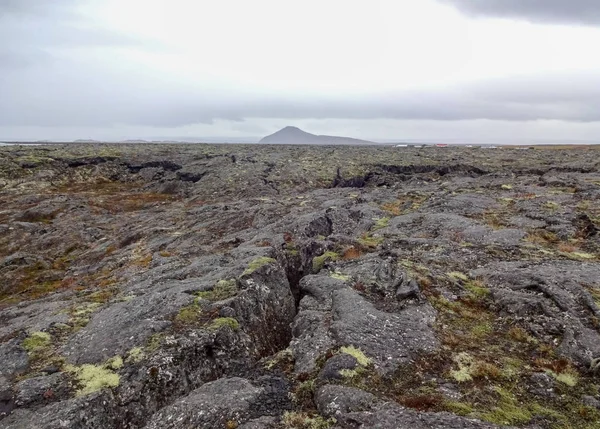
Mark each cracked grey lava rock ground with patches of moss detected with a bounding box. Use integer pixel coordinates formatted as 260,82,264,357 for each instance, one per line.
0,145,600,429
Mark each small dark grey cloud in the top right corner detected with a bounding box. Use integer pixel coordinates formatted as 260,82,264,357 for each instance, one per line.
440,0,600,25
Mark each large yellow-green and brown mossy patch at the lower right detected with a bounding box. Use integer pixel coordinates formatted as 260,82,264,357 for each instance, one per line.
324,270,600,429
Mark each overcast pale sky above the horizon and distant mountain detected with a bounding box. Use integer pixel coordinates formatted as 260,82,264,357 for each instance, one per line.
0,0,600,143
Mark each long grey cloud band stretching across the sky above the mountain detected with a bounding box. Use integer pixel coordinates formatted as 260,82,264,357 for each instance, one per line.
0,60,600,127
